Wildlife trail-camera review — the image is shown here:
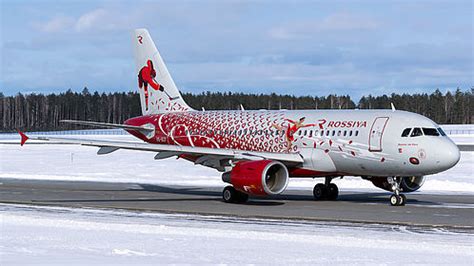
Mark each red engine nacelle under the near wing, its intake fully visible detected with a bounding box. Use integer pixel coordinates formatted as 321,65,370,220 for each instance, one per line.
222,160,289,195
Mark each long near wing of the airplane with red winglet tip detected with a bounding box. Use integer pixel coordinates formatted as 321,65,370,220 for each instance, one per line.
18,131,304,171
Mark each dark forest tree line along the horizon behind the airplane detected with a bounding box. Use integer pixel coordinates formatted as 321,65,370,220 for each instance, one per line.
0,88,474,132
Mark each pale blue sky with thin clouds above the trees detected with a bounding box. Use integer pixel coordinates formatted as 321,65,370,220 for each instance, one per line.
0,0,474,98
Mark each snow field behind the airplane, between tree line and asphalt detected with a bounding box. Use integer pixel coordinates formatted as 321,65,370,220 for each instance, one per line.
0,132,474,194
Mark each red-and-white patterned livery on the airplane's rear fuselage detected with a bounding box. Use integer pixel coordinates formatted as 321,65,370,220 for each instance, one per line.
125,111,290,153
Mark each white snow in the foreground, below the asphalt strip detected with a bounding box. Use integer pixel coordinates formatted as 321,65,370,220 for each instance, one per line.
0,205,474,265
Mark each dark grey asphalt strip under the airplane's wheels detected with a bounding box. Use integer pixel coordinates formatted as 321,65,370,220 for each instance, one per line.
0,179,474,231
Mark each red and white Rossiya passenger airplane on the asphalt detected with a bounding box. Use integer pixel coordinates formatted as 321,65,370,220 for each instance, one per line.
19,29,460,206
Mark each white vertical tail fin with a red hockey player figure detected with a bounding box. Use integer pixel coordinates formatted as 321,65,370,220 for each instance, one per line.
132,29,191,115
